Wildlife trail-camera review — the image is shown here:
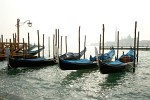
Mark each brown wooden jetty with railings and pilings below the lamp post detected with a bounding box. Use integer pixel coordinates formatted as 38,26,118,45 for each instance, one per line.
0,30,44,60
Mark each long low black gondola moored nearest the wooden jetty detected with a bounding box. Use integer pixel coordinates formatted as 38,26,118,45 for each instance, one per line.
8,57,56,68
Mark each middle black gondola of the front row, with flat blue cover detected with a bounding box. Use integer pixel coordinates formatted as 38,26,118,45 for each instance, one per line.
59,47,114,70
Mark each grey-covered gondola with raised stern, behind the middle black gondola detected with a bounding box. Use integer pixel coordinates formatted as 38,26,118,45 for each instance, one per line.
60,47,87,60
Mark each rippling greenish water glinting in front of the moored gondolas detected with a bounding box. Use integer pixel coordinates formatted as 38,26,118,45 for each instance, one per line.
0,47,150,100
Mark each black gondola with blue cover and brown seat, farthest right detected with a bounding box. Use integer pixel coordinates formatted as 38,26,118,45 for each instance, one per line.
99,48,135,74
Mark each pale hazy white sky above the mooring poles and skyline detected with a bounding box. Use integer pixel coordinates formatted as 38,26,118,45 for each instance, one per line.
0,0,150,45
